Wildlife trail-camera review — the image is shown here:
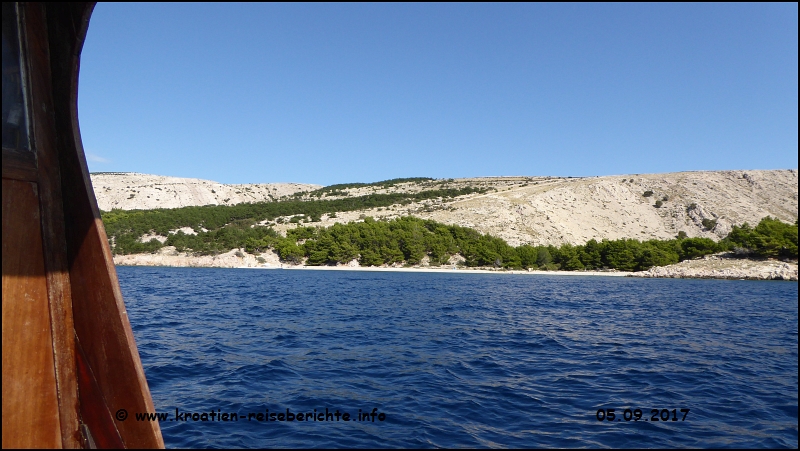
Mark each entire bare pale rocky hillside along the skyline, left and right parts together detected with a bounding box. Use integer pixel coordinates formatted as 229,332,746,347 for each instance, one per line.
92,169,798,246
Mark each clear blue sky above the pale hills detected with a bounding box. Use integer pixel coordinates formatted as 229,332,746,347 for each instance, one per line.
79,3,798,185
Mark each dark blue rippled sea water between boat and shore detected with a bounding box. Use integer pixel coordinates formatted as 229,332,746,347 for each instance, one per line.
118,267,798,448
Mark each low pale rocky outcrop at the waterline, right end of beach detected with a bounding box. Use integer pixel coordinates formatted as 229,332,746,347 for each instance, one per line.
629,254,797,281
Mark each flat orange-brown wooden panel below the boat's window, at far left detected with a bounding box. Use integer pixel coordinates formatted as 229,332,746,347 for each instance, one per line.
3,179,62,448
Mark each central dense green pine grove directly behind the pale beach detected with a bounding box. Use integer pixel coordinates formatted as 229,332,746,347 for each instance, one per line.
246,217,725,271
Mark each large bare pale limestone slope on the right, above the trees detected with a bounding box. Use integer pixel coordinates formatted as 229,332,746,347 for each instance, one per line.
416,169,798,246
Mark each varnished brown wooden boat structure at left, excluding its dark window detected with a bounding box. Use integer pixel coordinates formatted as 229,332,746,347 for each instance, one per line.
2,3,164,448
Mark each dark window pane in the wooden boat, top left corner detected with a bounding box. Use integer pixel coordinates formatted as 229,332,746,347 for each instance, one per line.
3,2,30,154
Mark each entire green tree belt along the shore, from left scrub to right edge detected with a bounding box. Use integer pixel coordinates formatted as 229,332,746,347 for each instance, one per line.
103,201,798,271
